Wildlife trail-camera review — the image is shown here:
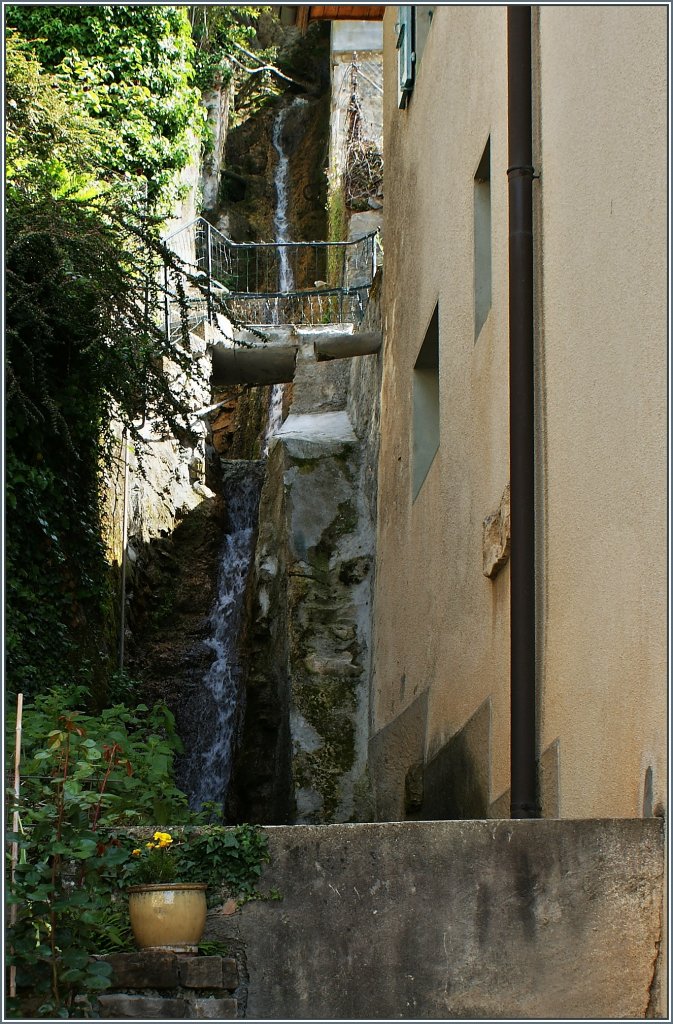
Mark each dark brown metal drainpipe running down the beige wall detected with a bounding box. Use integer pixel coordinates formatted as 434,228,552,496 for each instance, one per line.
507,0,539,818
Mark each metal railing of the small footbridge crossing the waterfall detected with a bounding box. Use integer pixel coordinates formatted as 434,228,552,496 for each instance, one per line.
159,217,379,335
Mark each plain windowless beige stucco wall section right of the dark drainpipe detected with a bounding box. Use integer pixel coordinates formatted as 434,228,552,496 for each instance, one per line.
539,5,667,816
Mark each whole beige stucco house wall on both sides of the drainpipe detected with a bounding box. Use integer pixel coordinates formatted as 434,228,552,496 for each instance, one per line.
372,5,667,817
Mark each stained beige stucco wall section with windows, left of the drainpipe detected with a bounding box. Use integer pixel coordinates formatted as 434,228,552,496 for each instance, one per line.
373,7,509,797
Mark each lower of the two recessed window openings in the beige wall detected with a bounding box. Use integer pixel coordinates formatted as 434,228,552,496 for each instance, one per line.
412,305,439,501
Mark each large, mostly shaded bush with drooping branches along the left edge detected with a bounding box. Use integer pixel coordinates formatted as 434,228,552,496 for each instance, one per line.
5,32,206,695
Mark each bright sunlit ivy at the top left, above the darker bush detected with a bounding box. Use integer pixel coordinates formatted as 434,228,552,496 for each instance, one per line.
5,4,203,201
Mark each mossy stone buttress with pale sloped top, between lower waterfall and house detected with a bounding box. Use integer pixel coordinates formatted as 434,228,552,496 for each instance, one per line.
229,328,376,823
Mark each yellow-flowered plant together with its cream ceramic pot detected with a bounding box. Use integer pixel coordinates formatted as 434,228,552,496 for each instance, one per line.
128,831,208,952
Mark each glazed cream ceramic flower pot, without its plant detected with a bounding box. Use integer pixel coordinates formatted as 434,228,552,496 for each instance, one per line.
128,882,207,953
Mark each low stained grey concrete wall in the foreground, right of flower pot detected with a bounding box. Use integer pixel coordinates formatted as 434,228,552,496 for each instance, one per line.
207,819,664,1020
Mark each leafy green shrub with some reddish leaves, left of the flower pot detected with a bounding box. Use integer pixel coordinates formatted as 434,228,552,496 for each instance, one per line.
7,690,190,1017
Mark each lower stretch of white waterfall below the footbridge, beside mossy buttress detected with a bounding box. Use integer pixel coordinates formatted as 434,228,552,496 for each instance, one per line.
188,461,262,809
